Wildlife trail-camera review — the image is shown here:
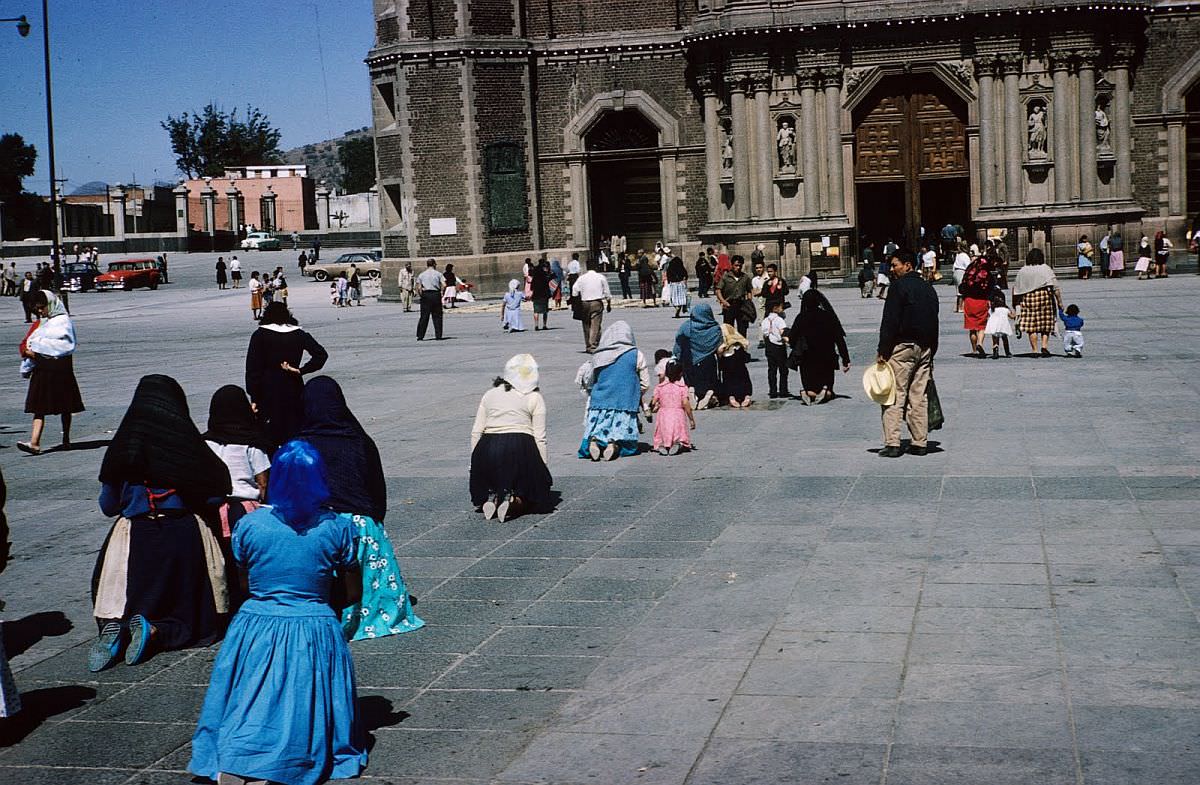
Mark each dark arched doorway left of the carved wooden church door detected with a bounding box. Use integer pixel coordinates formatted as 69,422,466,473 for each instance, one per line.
583,109,664,251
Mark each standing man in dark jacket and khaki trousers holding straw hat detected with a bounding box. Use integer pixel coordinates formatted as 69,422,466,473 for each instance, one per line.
876,251,937,457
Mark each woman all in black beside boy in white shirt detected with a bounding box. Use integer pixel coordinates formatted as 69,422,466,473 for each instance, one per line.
788,287,850,406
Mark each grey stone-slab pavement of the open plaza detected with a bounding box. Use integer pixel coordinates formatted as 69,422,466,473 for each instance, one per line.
0,252,1200,785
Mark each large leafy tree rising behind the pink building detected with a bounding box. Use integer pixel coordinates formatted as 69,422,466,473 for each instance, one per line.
160,103,282,178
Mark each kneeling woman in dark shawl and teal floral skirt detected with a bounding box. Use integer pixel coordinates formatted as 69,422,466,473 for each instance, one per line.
296,376,425,641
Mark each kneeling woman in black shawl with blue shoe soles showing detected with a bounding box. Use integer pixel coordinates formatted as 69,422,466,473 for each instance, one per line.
88,374,230,672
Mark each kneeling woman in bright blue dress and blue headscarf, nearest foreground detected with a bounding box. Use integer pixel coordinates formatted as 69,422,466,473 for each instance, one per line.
187,442,367,785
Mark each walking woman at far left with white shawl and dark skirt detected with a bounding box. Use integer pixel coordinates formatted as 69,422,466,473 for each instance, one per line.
17,290,84,455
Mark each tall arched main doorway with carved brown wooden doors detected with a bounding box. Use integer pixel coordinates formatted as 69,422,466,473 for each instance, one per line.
853,74,971,247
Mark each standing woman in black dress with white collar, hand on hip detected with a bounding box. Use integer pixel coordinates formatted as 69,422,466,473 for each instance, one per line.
246,302,329,447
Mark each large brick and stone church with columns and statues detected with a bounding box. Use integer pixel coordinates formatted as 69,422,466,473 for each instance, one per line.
367,0,1200,293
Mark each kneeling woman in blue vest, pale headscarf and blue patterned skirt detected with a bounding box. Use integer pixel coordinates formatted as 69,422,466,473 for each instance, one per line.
575,322,650,461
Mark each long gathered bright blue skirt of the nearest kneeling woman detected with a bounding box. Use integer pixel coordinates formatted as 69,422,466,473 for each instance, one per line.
187,606,367,785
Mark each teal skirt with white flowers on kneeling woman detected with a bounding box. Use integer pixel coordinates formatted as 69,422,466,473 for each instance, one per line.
340,513,425,641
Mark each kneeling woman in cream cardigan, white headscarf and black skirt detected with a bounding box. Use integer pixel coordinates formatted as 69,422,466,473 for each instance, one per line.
470,354,554,522
